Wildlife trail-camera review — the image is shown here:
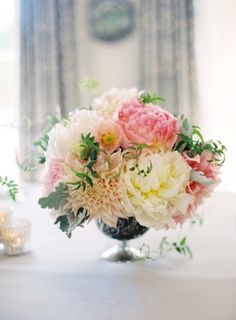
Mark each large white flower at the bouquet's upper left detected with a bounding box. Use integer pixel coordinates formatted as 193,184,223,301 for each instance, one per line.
46,110,100,160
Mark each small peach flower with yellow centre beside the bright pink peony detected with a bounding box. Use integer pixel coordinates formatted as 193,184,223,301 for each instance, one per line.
95,119,122,153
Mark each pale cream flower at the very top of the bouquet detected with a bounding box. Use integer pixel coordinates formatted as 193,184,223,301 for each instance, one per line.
92,88,139,119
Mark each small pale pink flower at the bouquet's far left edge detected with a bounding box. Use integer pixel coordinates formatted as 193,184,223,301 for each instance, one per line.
43,159,65,195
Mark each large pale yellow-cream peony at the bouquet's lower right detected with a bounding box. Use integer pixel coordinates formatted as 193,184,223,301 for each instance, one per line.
123,152,192,229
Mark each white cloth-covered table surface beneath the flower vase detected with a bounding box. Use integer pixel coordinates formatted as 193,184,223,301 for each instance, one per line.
0,184,236,320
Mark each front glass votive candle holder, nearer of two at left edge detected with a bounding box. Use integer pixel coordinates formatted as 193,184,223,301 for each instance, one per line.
1,218,31,256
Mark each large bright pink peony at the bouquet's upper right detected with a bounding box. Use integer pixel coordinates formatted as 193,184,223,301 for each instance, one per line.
118,100,179,150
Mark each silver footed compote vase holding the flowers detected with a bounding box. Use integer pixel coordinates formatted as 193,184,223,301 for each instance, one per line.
97,217,148,262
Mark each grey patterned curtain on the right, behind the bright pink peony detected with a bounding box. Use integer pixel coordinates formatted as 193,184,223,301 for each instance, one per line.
139,0,196,119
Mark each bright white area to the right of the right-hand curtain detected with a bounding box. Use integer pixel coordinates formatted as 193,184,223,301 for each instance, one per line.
195,0,236,191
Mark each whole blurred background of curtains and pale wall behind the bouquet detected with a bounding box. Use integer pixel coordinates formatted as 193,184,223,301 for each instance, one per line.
0,0,236,191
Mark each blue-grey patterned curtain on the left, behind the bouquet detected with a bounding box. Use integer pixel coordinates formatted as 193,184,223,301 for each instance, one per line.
20,0,78,169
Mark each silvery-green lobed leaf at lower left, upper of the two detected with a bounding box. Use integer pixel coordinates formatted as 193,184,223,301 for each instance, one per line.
38,183,68,210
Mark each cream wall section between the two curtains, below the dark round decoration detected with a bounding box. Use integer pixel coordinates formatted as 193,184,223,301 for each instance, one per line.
78,0,139,94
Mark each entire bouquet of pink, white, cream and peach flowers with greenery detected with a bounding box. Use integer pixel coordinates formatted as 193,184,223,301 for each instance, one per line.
39,89,225,237
